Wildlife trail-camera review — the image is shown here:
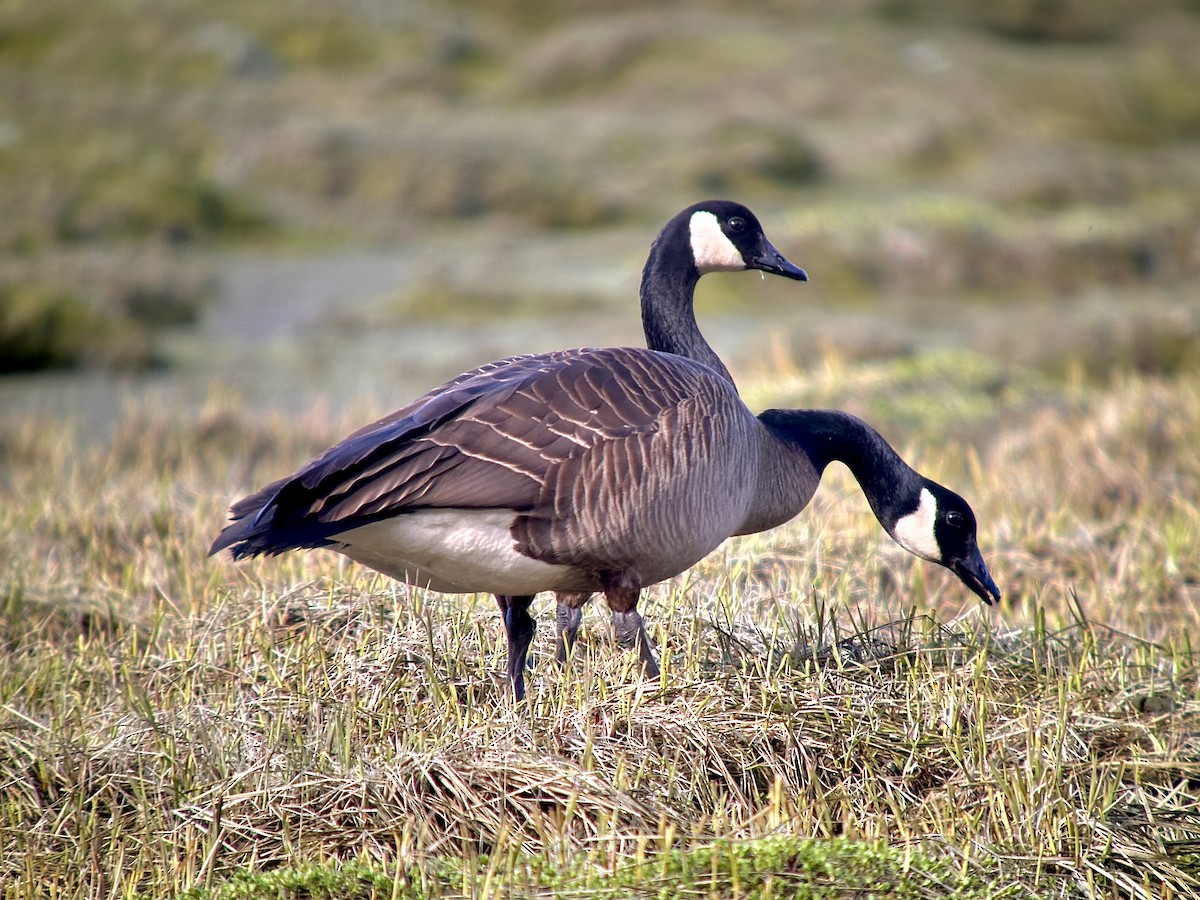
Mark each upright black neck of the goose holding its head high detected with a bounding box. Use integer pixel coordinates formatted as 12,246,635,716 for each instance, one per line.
641,232,733,384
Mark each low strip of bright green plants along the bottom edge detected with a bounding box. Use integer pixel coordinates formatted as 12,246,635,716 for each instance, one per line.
180,838,1024,900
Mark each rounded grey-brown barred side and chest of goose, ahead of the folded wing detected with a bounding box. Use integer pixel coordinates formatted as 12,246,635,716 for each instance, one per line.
514,354,757,580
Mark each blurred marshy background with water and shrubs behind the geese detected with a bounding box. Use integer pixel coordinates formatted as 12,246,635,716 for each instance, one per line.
0,0,1200,425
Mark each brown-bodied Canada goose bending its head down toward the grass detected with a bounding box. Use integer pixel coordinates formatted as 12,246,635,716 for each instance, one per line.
209,348,1000,700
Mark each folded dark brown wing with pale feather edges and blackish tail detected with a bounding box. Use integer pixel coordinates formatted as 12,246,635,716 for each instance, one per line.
212,348,712,556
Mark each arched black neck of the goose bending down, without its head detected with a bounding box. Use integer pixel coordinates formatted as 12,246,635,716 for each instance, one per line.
758,409,925,533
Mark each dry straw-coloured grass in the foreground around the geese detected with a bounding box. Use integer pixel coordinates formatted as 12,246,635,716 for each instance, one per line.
0,355,1200,900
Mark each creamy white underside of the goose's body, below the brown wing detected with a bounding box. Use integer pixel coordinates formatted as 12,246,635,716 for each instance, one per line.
334,509,580,596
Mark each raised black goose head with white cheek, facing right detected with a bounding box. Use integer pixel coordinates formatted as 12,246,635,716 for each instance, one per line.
677,200,809,281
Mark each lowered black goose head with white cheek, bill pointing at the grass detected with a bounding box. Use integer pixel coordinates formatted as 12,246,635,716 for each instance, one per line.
884,478,1000,606
